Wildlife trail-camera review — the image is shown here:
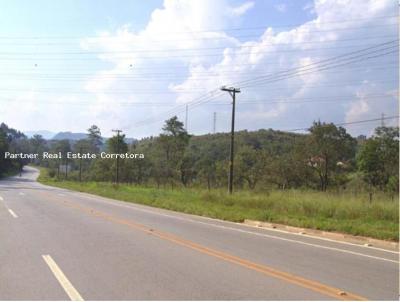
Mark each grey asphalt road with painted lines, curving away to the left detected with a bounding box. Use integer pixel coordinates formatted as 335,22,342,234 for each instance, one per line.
0,167,399,300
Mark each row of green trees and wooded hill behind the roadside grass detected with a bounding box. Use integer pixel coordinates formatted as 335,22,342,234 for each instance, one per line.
0,117,399,192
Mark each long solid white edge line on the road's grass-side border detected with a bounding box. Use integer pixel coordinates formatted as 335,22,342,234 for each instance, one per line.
67,192,400,264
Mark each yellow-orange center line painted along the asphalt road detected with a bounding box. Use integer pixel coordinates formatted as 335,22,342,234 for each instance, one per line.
38,192,368,301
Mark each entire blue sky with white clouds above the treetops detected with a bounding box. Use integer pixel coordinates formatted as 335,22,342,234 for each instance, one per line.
0,0,399,138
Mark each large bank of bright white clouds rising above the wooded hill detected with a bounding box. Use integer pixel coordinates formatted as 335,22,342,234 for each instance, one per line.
0,0,398,137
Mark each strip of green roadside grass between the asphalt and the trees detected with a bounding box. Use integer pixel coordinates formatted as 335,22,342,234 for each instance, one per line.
38,168,399,241
